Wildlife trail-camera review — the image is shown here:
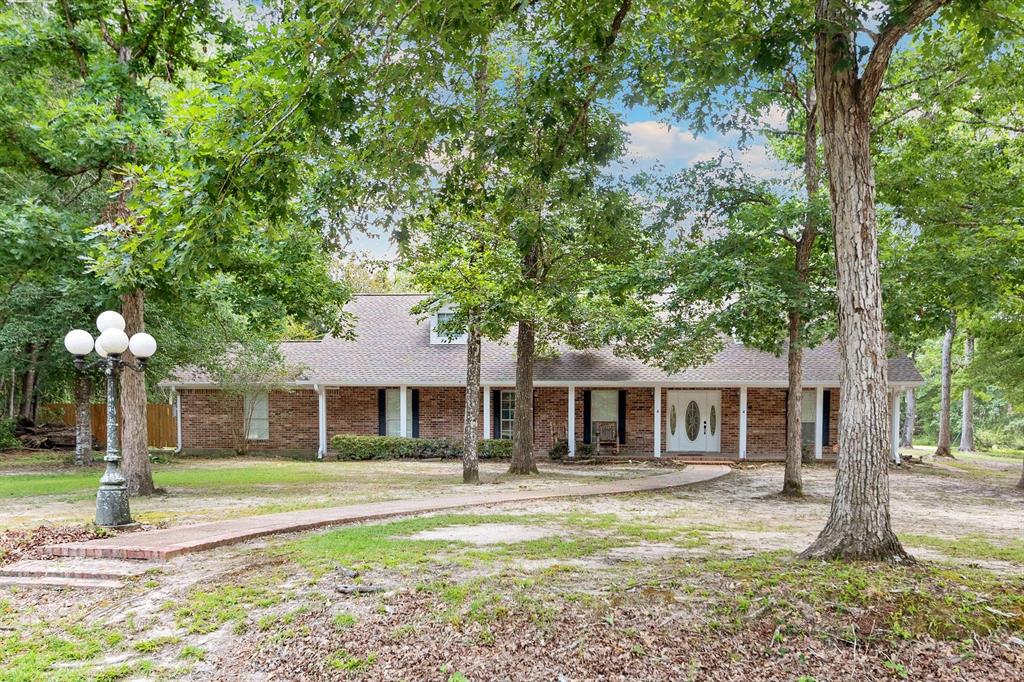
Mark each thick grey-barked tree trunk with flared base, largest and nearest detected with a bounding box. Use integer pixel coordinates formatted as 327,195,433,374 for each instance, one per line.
802,0,912,561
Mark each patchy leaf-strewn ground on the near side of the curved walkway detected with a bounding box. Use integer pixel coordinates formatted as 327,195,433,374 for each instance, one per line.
0,450,1024,681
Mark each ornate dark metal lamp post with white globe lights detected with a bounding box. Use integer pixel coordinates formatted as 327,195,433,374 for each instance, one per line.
65,310,157,527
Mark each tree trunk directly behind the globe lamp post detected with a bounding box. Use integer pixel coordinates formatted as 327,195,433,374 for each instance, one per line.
121,289,156,495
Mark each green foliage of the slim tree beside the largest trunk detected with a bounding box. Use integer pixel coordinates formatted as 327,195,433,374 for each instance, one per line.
607,159,836,372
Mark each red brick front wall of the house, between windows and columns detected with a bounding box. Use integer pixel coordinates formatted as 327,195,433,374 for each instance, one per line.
179,386,839,460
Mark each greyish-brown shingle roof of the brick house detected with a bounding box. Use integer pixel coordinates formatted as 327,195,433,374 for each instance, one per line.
166,294,923,386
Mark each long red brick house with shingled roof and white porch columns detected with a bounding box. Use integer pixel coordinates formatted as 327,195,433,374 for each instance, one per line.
164,295,923,460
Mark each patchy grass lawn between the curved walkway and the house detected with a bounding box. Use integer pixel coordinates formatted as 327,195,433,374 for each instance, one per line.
0,453,638,529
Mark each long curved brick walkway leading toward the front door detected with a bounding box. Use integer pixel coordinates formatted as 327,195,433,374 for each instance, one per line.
46,465,729,561
